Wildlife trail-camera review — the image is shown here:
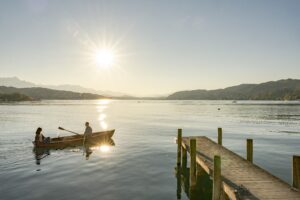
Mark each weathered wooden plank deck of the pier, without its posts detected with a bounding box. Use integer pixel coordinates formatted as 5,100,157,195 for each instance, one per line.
182,136,300,200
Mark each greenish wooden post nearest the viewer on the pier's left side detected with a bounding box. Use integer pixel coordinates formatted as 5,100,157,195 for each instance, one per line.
212,155,222,200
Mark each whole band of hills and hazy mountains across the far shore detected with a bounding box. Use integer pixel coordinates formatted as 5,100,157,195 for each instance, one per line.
0,77,300,100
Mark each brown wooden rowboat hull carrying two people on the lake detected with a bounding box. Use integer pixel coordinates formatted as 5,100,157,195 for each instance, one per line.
32,129,115,149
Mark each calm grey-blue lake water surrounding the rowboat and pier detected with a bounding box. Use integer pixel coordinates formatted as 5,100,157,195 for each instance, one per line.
0,100,300,200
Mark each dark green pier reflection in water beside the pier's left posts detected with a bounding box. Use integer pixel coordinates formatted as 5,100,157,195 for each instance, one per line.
175,166,212,200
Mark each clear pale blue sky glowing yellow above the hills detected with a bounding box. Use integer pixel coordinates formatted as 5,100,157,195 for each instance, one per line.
0,0,300,96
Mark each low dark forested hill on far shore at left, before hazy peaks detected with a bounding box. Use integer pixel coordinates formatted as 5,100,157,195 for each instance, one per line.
0,86,105,101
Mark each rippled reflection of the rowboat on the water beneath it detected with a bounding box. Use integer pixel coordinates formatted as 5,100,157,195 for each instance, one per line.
33,138,115,165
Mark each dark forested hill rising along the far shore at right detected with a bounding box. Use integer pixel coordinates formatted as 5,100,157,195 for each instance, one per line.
167,79,300,100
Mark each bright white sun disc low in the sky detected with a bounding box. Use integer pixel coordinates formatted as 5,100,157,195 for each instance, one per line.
94,49,114,67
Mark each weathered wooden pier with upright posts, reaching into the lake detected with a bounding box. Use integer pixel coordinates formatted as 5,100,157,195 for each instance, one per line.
177,128,300,200
